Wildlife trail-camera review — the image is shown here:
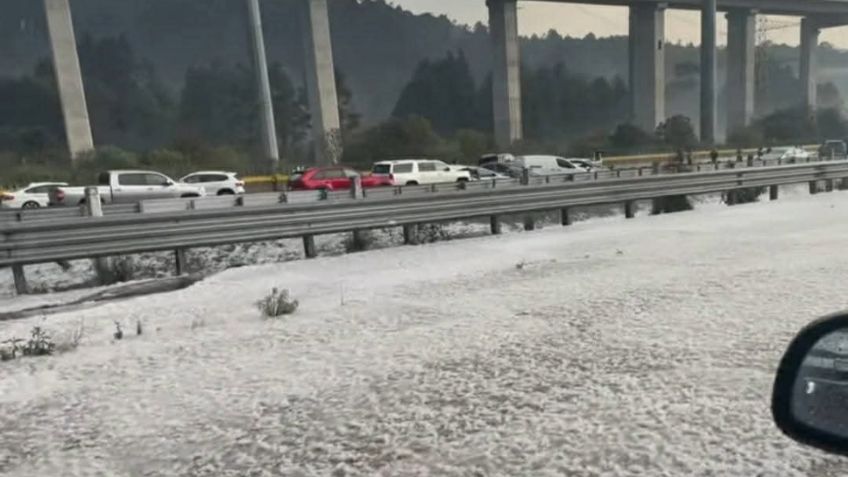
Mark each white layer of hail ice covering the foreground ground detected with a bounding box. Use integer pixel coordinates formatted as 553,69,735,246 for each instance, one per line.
0,188,848,477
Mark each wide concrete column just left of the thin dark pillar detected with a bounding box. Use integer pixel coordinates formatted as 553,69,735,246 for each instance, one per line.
630,4,665,132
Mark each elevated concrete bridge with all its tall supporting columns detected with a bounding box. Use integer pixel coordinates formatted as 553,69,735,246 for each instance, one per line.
43,0,848,164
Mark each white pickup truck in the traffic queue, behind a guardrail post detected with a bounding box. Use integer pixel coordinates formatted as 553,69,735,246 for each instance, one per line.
50,171,206,206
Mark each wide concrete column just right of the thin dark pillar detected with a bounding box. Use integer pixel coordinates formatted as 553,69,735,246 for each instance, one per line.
727,10,757,133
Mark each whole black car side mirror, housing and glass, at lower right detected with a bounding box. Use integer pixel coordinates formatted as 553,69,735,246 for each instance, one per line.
772,312,848,456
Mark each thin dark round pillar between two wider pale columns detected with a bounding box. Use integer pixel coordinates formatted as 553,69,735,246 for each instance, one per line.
701,0,716,145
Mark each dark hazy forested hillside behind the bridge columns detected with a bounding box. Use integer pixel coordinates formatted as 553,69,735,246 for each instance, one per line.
0,0,848,184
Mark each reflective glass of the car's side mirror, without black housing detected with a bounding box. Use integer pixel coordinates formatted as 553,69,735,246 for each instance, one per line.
791,328,848,438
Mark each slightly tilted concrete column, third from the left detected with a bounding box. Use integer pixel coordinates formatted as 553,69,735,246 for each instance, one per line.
304,0,342,165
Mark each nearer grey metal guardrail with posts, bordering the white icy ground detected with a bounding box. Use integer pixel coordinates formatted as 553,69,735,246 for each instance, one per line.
0,161,848,293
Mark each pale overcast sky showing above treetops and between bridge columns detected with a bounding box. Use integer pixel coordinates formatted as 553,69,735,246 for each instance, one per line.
391,0,848,48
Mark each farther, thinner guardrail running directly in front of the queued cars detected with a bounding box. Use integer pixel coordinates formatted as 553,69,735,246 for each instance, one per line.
0,154,816,224
